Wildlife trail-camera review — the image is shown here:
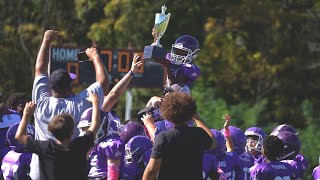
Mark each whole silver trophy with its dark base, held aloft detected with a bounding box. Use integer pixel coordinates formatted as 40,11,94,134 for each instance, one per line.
143,5,171,61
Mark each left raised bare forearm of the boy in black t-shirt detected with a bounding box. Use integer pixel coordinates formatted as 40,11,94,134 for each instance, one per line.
15,102,36,145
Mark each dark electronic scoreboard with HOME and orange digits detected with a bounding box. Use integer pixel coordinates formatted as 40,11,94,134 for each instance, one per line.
50,47,166,88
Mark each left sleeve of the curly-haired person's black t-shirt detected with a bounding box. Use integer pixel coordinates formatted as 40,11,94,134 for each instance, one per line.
151,133,167,159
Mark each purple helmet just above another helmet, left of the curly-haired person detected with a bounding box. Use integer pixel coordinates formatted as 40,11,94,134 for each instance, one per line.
120,121,146,143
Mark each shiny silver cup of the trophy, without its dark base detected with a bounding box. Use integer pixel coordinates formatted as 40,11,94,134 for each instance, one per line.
151,5,171,47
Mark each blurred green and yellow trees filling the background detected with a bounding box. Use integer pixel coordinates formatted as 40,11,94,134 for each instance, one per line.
0,0,320,179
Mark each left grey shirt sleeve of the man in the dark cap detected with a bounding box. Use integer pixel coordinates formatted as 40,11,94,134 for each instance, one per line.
32,74,51,103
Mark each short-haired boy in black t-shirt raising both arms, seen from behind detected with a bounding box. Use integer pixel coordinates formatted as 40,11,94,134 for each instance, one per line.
16,94,100,180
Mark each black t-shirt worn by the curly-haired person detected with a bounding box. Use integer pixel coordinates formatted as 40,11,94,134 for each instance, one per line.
151,126,212,180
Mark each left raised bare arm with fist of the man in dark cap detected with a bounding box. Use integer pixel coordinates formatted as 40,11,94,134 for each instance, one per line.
34,30,58,77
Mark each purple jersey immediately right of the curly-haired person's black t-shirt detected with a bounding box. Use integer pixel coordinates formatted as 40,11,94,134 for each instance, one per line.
202,153,218,180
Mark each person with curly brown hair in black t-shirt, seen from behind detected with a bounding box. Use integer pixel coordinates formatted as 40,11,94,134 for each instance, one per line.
143,92,216,180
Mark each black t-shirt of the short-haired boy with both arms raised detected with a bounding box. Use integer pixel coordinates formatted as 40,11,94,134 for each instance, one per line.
27,131,94,180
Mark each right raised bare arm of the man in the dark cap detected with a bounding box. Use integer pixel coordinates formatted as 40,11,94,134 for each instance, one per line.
86,47,110,92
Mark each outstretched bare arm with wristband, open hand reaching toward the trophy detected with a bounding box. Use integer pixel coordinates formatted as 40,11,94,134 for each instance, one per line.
102,54,142,112
